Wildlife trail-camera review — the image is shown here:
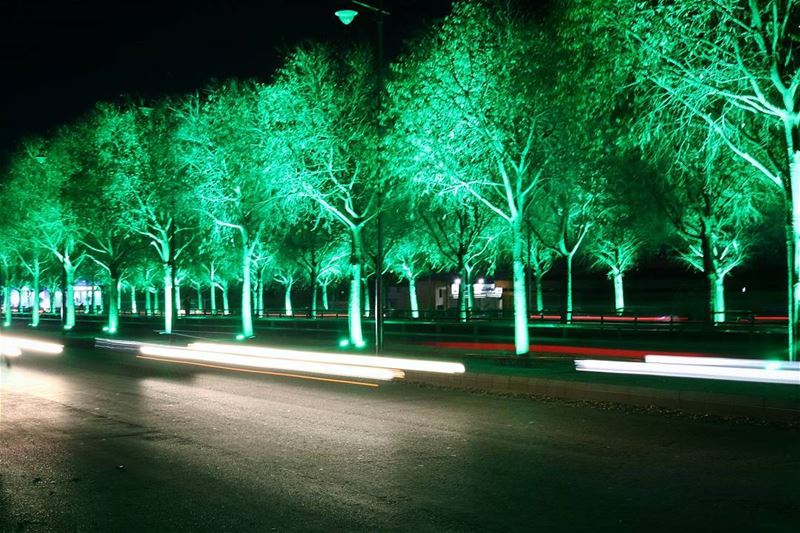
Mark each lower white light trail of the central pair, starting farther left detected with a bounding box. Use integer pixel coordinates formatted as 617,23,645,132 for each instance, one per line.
140,345,405,381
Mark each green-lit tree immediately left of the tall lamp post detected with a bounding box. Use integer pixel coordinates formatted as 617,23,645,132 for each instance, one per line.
268,46,387,347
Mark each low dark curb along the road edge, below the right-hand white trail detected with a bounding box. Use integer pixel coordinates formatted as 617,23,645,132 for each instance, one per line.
406,371,800,424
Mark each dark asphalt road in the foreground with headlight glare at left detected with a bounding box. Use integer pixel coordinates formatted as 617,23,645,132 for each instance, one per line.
0,348,800,532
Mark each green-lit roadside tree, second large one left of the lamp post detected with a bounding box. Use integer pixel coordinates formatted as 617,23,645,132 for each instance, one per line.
180,82,290,337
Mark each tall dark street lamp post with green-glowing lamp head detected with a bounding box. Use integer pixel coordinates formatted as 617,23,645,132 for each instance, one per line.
335,0,389,354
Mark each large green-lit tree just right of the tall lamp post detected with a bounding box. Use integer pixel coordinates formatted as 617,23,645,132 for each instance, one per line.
390,2,553,355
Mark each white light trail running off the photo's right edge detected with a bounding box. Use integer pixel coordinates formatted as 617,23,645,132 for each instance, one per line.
575,359,800,385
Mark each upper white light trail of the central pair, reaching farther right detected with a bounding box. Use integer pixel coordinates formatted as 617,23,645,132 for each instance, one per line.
188,342,465,374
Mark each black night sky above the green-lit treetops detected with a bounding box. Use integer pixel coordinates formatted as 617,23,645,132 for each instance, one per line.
0,0,451,160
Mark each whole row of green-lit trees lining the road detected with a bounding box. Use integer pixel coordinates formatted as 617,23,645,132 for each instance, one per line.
0,0,800,354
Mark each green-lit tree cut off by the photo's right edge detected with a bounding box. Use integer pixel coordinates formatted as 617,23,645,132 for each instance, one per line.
620,0,800,359
